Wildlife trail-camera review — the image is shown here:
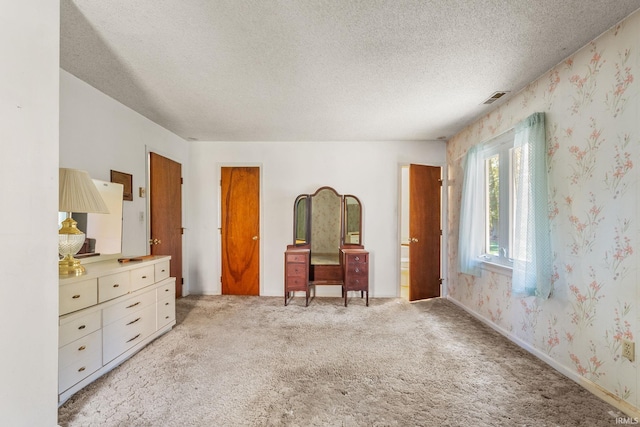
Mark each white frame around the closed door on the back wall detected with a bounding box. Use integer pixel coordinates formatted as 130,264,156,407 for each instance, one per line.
216,162,265,296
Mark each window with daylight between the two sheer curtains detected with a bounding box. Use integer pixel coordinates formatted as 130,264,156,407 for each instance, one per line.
478,131,518,266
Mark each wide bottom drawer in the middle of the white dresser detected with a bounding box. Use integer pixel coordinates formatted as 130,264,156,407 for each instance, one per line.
102,304,156,364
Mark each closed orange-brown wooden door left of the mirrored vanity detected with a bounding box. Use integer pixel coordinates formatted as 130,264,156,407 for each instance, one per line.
220,167,260,295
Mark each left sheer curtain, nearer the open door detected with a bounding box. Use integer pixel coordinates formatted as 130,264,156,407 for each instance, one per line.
458,144,484,276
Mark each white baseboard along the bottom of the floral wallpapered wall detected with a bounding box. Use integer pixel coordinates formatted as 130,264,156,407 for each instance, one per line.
445,296,640,419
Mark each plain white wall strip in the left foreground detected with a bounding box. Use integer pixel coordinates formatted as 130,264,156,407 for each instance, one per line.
0,0,60,426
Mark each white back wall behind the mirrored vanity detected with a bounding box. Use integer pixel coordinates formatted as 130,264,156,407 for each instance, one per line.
188,141,445,297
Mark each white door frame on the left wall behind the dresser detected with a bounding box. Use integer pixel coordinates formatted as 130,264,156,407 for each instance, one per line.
144,144,186,297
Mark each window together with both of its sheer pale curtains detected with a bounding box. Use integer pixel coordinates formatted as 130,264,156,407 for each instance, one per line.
458,113,553,298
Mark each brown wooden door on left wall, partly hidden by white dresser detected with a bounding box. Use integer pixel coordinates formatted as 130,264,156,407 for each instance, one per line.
149,153,182,298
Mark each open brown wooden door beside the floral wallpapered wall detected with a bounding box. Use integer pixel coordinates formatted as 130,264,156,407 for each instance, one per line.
409,165,442,301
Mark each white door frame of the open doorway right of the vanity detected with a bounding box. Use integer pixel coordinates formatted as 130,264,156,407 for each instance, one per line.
395,162,449,298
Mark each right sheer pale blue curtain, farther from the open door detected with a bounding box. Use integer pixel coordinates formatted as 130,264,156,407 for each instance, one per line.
511,113,553,298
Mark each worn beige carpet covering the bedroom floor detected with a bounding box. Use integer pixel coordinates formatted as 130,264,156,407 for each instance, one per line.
59,296,623,427
